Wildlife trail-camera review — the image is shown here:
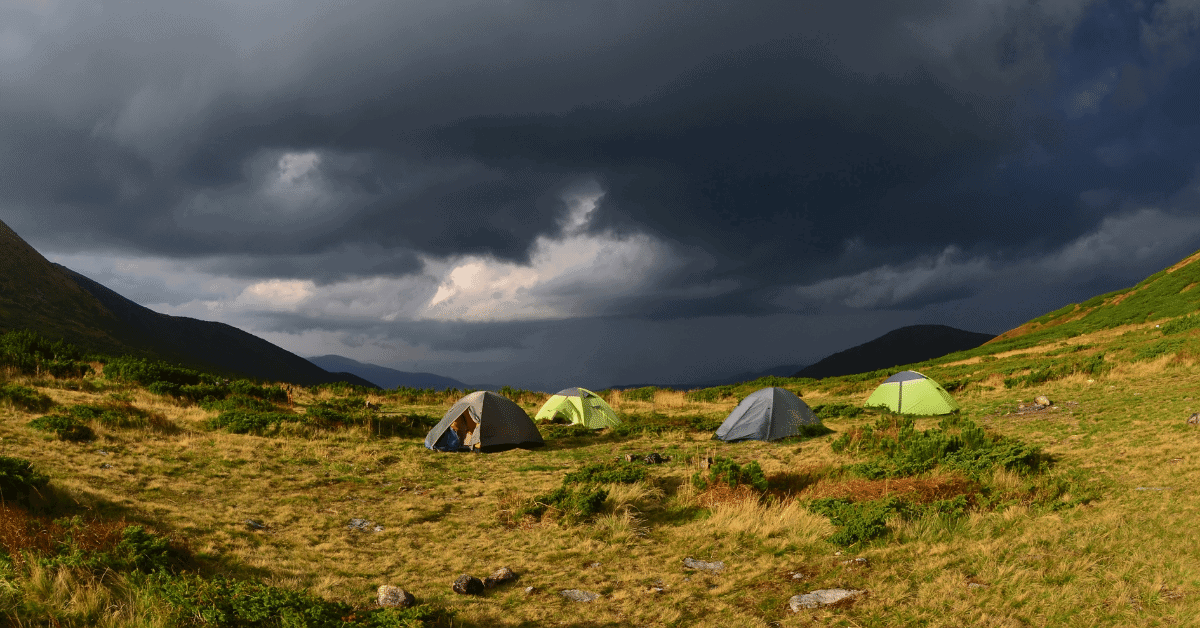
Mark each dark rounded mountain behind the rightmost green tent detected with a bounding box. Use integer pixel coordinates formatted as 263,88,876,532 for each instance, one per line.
792,325,996,379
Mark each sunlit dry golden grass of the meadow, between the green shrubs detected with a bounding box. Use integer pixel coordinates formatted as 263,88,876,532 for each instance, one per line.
7,327,1200,627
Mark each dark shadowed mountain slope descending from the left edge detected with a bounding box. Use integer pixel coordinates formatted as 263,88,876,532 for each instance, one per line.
0,217,374,388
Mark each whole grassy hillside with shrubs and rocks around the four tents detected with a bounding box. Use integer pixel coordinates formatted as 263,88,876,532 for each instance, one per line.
0,250,1200,627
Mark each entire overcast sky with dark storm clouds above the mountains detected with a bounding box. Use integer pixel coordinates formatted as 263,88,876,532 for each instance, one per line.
0,0,1200,390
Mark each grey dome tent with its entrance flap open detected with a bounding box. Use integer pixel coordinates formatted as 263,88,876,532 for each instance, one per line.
425,390,545,451
